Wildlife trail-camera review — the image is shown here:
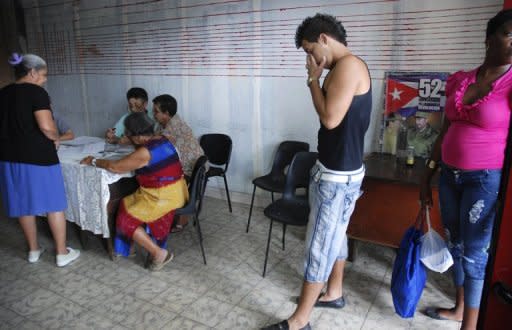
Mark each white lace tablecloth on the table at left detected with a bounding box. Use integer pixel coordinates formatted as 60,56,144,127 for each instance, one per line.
58,136,134,238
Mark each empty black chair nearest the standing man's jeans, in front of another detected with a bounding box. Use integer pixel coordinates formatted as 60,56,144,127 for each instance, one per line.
263,151,318,277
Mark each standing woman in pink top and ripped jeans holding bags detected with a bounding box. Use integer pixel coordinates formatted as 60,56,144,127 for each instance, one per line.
420,10,512,329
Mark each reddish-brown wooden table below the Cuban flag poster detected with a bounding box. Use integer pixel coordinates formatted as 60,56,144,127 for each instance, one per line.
347,153,444,250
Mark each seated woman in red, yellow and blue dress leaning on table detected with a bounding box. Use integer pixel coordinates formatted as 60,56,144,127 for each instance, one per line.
81,113,188,271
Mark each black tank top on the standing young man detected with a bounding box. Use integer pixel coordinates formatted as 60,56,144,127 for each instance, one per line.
318,83,372,171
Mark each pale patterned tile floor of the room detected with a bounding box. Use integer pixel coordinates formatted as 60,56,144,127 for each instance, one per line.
0,198,460,329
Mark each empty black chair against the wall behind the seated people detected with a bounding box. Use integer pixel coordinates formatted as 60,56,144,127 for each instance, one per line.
199,134,233,212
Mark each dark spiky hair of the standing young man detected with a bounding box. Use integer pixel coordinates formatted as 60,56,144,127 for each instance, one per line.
295,14,347,49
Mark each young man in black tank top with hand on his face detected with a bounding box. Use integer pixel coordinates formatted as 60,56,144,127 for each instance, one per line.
265,14,372,330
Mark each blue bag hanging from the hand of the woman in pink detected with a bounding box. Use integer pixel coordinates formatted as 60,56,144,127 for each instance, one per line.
391,209,427,318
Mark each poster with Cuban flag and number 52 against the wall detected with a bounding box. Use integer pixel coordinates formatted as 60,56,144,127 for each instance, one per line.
379,72,449,156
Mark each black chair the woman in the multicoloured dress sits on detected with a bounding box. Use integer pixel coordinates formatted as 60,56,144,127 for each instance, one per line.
175,156,207,265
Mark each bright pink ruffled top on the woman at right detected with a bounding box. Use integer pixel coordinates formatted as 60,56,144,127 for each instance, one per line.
441,68,512,170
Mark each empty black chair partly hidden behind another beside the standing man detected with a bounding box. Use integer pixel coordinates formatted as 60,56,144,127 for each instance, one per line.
245,141,309,233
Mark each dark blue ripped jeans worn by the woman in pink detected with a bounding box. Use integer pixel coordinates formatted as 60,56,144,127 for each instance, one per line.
439,165,501,308
